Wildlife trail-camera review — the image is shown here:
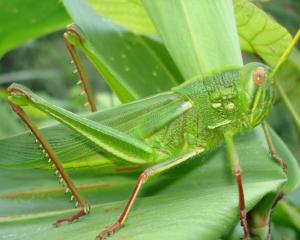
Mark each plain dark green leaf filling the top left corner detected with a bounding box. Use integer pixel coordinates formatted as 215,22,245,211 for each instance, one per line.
0,0,70,57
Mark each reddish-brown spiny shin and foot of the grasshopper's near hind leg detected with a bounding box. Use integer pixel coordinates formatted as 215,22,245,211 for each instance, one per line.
10,102,90,226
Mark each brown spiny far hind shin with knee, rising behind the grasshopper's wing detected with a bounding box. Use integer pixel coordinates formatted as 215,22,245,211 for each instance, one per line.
64,25,97,112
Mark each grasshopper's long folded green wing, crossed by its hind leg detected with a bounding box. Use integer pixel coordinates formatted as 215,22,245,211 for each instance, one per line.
0,86,191,166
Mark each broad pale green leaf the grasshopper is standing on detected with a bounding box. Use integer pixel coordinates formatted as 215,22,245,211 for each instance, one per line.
0,126,299,240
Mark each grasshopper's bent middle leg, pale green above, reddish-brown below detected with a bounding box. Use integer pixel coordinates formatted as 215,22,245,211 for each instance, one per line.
96,148,204,240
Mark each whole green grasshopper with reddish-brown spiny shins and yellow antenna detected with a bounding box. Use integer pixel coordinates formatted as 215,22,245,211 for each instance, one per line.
8,23,300,240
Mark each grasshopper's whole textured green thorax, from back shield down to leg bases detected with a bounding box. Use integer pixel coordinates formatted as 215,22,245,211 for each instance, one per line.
144,70,244,160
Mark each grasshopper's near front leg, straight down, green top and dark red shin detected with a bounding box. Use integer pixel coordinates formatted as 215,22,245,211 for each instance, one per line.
224,133,250,240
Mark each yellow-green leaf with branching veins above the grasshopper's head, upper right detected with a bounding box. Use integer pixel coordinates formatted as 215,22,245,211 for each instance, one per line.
234,0,292,67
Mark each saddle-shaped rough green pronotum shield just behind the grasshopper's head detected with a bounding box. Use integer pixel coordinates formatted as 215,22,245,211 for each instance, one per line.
173,69,244,137
